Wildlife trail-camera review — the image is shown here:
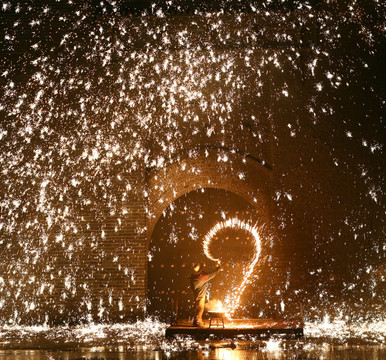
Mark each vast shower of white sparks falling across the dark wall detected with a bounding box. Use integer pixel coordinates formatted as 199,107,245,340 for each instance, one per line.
0,0,386,324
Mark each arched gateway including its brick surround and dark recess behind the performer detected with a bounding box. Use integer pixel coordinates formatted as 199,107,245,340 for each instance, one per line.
143,148,273,318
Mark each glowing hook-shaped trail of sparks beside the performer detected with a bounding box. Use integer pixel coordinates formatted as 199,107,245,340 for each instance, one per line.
203,218,261,316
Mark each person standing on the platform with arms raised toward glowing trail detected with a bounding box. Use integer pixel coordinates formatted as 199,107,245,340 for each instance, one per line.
190,263,223,326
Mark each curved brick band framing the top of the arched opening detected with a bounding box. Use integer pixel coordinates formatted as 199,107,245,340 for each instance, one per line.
148,148,272,238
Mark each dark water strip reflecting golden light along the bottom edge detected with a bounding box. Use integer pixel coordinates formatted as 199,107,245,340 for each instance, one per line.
0,343,386,360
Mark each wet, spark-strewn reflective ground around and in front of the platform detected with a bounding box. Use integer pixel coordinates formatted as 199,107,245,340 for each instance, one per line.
0,319,386,360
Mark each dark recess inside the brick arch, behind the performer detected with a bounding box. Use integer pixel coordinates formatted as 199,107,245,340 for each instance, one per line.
148,188,270,319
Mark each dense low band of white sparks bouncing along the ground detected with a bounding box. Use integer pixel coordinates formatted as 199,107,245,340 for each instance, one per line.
0,318,386,352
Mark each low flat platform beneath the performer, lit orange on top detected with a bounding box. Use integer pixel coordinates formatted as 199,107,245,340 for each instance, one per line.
165,319,303,339
